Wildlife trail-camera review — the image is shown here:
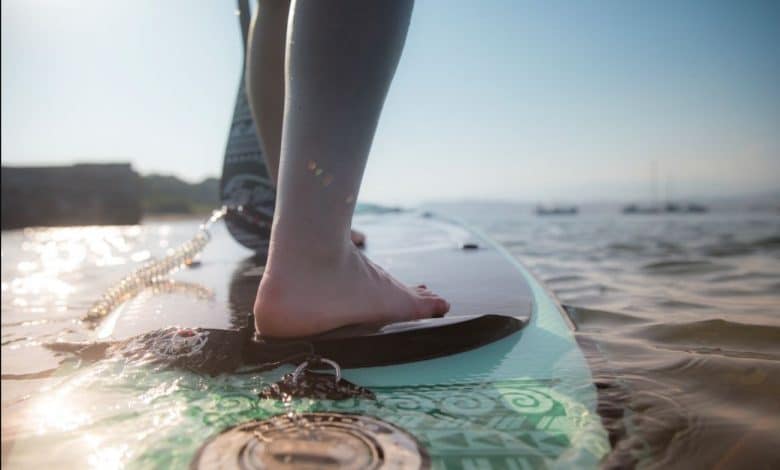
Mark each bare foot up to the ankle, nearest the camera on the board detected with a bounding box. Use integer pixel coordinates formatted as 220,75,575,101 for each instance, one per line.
254,243,450,337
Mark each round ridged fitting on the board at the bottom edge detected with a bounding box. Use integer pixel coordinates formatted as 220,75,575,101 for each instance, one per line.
191,413,430,469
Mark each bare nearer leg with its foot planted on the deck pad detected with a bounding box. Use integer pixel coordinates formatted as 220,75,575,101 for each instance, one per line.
254,0,449,336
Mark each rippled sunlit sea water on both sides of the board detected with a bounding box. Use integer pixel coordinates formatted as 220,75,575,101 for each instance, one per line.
2,204,780,469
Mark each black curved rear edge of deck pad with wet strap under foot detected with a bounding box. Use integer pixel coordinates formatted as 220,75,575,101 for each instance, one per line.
47,315,524,375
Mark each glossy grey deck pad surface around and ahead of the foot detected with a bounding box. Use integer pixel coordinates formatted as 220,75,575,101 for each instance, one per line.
99,213,532,339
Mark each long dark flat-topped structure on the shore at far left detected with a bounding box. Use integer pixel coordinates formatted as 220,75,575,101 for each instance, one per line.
2,164,143,230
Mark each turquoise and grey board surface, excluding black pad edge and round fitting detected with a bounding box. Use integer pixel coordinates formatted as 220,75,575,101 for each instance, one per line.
3,213,610,469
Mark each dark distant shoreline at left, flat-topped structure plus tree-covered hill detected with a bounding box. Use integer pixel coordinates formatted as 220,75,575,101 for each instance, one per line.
1,163,221,230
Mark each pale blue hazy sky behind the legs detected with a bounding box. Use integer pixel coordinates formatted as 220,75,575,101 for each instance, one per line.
1,0,780,203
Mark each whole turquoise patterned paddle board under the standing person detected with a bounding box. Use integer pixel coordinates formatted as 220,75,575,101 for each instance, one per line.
7,212,610,469
